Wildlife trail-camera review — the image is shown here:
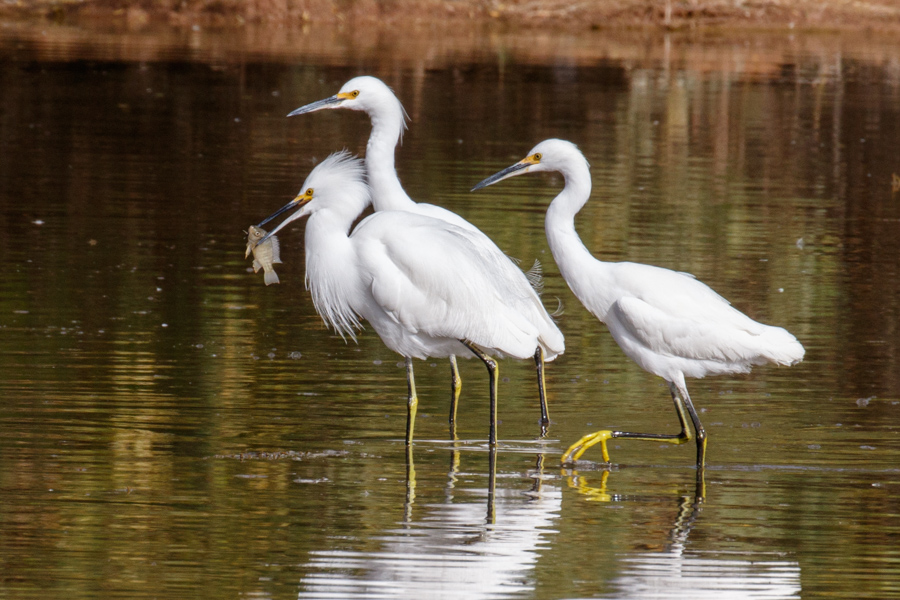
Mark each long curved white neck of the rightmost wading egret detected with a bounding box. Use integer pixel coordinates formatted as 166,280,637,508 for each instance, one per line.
544,158,613,320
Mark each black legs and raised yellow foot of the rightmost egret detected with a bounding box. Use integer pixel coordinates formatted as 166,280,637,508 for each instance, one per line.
562,377,706,468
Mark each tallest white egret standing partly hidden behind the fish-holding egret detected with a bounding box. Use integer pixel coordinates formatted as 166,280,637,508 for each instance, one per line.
288,75,565,431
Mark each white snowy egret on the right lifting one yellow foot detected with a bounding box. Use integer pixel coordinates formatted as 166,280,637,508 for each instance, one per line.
473,139,804,470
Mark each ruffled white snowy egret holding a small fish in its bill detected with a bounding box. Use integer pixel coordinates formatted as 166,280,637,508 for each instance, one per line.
258,152,564,445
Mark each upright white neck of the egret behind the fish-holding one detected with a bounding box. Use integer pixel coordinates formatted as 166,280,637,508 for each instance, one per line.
366,98,415,211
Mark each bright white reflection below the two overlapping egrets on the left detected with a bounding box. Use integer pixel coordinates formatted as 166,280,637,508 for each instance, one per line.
298,450,562,600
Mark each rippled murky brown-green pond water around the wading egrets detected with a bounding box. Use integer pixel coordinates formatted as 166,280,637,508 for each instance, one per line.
0,21,900,598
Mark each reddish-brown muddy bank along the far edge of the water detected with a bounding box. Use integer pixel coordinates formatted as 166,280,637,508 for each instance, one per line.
0,0,900,31
